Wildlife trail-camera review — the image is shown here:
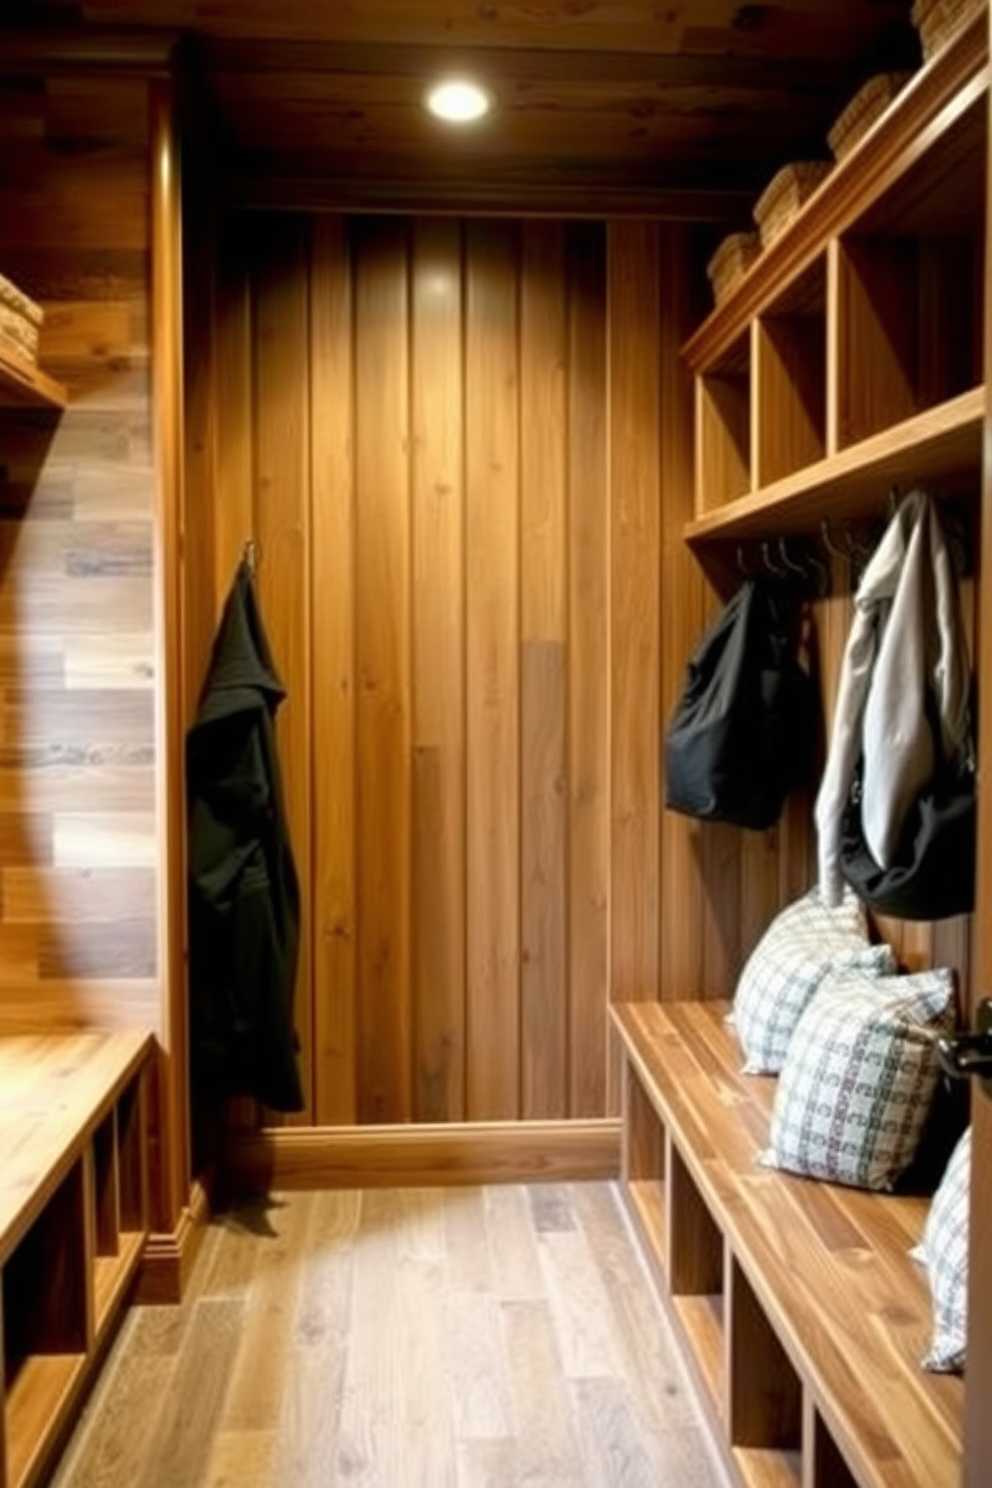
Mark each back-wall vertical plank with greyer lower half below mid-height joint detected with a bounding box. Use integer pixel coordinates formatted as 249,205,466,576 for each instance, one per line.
521,223,568,1117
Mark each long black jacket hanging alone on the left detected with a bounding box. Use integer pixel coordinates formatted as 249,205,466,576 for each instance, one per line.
186,562,303,1112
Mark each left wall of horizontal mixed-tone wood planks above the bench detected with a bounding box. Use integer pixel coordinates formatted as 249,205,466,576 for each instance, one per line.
0,73,159,1031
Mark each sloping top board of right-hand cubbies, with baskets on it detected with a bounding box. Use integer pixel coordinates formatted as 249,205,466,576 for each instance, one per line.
683,12,989,372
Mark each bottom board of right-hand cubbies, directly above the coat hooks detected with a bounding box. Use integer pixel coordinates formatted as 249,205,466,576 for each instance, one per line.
684,387,985,543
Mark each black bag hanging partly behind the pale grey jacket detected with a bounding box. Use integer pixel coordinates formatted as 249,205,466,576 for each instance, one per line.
840,755,977,920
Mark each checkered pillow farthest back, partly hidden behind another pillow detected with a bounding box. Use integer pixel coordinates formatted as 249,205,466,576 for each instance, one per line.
732,888,895,1074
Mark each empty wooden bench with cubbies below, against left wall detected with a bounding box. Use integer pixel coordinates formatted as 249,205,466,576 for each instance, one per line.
0,1033,152,1488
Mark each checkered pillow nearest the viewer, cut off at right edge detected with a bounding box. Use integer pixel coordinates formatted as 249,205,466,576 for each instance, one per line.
913,1129,971,1373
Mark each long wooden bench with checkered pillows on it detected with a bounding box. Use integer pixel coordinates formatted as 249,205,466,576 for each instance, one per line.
613,1003,964,1488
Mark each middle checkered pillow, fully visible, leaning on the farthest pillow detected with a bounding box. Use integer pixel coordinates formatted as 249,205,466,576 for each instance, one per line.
761,969,955,1189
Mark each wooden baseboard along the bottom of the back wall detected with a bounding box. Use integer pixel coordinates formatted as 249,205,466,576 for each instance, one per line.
226,1120,620,1190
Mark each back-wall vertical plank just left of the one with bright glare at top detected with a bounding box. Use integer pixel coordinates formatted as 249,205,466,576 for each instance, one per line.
355,222,412,1120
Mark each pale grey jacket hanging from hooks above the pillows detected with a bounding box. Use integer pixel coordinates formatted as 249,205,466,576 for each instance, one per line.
817,491,971,905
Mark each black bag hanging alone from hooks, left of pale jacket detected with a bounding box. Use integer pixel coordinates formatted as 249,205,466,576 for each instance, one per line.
665,579,817,830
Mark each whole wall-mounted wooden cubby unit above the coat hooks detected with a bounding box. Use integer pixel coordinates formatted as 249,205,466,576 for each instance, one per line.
684,15,989,543
